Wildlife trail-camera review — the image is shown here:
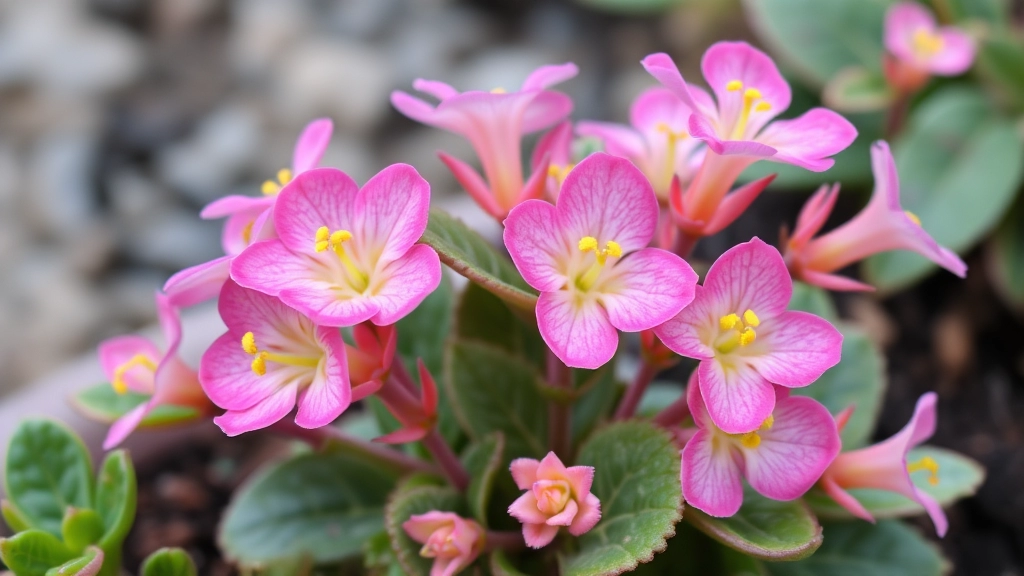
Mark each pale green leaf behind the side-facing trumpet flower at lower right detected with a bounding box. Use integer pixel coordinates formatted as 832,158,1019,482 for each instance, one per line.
804,446,985,520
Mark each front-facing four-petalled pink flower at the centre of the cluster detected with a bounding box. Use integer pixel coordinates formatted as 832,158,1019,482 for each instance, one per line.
505,154,697,368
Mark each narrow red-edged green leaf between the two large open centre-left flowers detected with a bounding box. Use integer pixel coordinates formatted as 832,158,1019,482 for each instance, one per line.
420,209,537,312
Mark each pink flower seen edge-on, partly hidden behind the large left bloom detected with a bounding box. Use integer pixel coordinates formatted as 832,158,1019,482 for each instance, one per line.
164,118,334,306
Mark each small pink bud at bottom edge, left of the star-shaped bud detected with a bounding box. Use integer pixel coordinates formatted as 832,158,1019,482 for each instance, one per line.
401,510,485,576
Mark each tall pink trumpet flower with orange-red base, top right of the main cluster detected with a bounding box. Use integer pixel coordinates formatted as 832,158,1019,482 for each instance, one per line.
642,42,857,237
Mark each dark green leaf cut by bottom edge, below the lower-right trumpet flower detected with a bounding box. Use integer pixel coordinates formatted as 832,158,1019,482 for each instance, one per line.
765,520,949,576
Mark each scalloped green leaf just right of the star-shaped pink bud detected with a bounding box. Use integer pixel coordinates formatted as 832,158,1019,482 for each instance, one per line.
559,421,689,576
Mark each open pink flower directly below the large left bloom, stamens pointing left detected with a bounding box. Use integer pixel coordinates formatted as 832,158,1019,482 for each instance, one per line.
199,282,352,436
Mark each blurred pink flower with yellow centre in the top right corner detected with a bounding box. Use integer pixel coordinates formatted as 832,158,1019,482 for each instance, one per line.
884,2,975,93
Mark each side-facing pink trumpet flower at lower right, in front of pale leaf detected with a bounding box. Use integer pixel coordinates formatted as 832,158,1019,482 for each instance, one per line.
820,393,949,536
